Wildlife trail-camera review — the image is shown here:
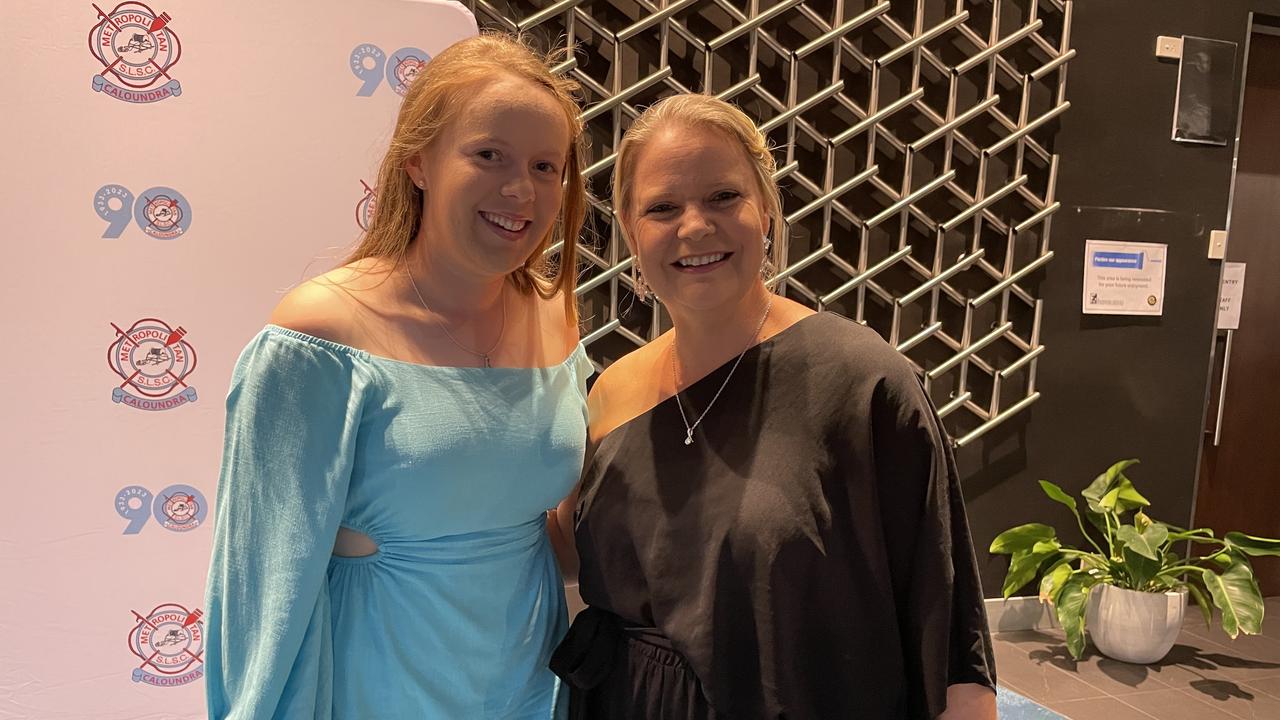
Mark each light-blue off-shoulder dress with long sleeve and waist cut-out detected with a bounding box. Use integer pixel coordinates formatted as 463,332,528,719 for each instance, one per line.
205,325,591,720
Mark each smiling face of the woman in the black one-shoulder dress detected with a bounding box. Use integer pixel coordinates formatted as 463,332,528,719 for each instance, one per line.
622,123,769,313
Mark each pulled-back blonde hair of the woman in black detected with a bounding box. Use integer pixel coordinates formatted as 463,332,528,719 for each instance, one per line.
613,92,783,274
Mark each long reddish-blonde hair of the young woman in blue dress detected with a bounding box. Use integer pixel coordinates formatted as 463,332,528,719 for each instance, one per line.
344,32,588,322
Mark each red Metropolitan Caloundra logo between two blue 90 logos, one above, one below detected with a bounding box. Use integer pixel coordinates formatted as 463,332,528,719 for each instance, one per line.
106,318,196,410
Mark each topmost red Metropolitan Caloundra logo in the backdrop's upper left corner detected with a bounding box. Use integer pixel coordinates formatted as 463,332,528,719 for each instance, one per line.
88,3,182,104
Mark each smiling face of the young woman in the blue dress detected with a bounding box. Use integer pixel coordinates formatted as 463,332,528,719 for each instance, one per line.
406,76,570,277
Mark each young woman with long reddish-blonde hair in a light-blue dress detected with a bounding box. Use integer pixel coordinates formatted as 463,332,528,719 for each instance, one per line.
205,35,591,720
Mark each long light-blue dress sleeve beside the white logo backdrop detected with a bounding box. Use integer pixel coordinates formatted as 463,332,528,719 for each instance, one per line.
205,328,369,720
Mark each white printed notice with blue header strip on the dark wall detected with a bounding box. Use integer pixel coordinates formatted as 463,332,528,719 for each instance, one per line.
1083,240,1169,315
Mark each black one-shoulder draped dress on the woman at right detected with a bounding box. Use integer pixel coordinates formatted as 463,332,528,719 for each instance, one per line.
552,313,996,720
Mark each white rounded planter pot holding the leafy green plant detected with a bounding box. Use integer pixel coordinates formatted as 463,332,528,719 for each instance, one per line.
1085,585,1187,665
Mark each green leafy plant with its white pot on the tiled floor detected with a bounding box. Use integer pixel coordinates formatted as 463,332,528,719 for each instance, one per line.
991,460,1280,664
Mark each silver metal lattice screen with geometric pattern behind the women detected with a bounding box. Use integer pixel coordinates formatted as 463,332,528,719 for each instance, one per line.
467,0,1075,446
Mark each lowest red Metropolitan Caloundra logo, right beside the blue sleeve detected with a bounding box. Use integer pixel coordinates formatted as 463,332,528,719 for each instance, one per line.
129,602,205,688
